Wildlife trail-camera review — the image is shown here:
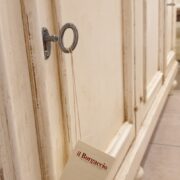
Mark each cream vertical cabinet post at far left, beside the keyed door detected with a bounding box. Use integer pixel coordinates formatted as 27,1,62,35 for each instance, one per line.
0,0,41,180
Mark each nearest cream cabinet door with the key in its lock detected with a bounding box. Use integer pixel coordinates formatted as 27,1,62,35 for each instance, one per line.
22,0,135,180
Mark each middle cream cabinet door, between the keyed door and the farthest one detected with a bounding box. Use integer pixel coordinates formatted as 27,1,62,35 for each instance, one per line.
135,0,163,129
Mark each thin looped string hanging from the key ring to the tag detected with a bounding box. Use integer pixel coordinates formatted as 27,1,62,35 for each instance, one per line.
69,48,81,139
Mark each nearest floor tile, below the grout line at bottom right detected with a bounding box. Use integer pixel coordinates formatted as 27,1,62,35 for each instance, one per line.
143,144,180,180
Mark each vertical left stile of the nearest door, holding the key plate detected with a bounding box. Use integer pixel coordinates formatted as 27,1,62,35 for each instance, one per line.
21,0,68,180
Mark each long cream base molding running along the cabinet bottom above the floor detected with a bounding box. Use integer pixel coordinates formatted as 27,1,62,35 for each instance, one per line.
115,61,178,180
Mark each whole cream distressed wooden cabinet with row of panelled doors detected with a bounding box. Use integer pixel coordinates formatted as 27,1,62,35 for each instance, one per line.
0,0,177,180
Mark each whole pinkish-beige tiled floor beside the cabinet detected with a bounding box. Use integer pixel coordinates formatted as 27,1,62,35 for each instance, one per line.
143,82,180,180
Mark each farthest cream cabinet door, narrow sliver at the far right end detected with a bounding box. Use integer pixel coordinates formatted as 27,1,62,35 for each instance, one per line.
164,0,176,75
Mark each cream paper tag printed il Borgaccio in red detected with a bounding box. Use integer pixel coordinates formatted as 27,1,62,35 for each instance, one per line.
61,142,115,180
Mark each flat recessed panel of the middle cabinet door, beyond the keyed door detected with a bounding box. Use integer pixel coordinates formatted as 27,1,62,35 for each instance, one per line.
146,0,159,85
